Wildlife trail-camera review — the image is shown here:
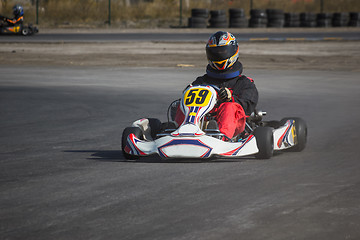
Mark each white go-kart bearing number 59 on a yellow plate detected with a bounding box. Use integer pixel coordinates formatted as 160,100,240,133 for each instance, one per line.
122,85,307,160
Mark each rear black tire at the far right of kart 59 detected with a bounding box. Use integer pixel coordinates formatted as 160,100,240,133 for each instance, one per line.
280,117,307,152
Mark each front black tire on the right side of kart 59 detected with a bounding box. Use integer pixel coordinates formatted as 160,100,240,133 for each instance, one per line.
254,127,274,159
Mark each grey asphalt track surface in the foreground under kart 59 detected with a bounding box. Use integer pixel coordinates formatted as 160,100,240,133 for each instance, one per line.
0,65,360,240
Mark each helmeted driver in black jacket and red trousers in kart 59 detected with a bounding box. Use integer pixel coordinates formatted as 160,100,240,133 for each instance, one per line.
175,31,258,138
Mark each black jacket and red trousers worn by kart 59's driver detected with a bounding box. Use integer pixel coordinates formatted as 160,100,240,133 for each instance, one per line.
175,62,259,138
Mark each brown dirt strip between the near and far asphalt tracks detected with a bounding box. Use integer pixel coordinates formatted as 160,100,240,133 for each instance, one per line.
0,37,360,71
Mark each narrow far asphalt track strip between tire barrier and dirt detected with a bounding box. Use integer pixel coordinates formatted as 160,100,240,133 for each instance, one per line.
0,29,360,43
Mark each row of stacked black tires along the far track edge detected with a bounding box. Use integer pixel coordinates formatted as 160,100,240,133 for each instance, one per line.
188,8,360,28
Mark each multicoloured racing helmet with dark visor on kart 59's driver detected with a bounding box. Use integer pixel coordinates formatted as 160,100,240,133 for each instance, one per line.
206,31,239,71
